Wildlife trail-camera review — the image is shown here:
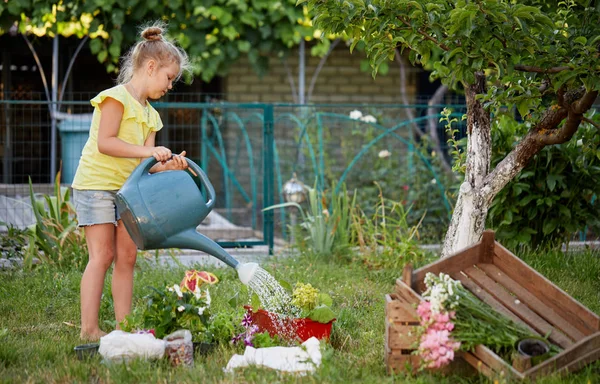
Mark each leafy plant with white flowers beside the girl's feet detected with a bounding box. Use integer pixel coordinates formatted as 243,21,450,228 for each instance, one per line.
122,271,217,341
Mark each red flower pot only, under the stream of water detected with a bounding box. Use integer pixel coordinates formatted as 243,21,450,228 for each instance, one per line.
244,306,335,341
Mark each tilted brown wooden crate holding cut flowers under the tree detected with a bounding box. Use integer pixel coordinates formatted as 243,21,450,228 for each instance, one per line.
386,231,600,380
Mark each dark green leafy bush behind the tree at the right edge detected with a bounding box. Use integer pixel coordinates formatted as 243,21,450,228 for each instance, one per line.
488,117,600,247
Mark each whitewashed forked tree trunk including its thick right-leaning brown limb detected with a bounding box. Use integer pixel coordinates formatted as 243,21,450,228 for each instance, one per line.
441,84,598,257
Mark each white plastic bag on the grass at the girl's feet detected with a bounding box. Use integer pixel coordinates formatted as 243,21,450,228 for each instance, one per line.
98,330,165,360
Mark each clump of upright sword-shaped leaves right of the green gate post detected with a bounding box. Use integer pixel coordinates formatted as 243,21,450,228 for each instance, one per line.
264,185,355,256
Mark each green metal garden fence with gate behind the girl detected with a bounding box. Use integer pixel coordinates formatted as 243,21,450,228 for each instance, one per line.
0,95,465,246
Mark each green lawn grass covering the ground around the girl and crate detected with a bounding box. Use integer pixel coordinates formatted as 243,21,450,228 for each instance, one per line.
0,248,600,384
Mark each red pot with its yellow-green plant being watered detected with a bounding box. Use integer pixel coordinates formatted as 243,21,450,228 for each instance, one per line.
245,283,335,342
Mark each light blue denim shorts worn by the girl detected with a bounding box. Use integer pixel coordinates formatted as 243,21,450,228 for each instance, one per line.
73,189,121,227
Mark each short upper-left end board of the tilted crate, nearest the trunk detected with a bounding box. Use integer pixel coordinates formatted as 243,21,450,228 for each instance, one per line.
412,242,481,294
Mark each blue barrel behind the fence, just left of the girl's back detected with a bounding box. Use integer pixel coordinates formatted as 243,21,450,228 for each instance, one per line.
58,116,92,184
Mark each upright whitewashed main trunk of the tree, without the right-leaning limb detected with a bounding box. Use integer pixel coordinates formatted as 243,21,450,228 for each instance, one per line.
441,72,492,257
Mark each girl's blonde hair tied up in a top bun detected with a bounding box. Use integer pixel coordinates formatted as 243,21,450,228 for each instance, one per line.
117,21,191,84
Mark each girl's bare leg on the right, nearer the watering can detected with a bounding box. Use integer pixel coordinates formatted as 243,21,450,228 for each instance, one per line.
112,220,137,329
